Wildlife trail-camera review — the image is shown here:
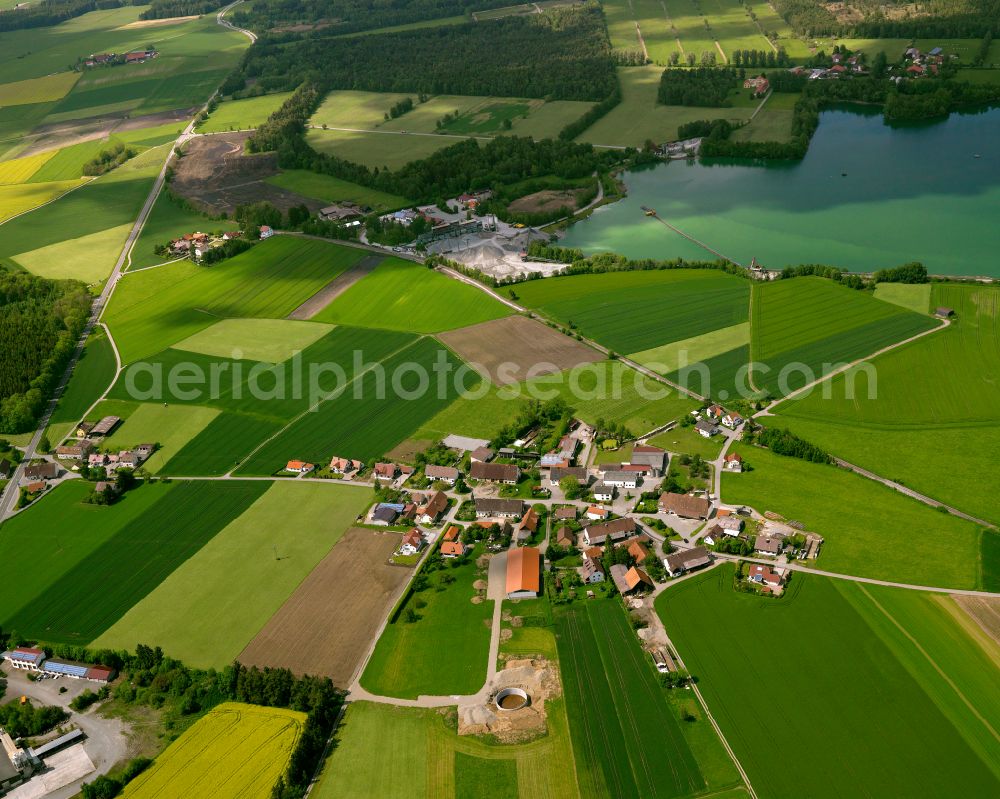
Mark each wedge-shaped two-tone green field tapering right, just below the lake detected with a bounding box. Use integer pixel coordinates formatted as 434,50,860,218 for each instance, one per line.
750,277,936,396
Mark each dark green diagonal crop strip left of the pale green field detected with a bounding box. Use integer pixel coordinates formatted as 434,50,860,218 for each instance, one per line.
1,481,268,644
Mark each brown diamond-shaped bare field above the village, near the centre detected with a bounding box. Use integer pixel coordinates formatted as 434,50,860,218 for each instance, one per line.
439,316,603,385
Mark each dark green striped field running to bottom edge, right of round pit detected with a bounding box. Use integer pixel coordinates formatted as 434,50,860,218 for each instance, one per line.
556,600,708,797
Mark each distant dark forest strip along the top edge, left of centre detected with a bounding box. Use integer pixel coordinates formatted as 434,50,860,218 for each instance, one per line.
233,0,510,34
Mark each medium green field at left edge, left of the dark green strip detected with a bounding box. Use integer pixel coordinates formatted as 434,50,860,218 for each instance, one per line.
0,480,177,639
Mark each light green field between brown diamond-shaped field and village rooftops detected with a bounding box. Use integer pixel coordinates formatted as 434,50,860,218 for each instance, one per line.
414,361,696,441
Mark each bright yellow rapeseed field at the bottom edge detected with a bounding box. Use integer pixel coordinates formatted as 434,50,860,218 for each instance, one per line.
122,702,306,799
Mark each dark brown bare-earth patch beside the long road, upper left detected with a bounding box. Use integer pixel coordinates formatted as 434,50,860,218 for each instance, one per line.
171,132,323,216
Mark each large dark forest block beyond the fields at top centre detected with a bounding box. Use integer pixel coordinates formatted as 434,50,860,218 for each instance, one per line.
231,5,617,101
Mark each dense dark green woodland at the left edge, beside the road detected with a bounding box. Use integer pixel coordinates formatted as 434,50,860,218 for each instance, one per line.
0,267,90,433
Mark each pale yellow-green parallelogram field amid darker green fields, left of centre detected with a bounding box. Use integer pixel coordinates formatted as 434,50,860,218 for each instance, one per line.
174,319,333,363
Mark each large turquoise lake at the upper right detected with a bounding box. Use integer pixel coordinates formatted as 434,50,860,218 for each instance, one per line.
562,109,1000,277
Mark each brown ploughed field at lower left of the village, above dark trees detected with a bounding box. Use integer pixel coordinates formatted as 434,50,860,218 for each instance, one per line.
238,527,411,687
